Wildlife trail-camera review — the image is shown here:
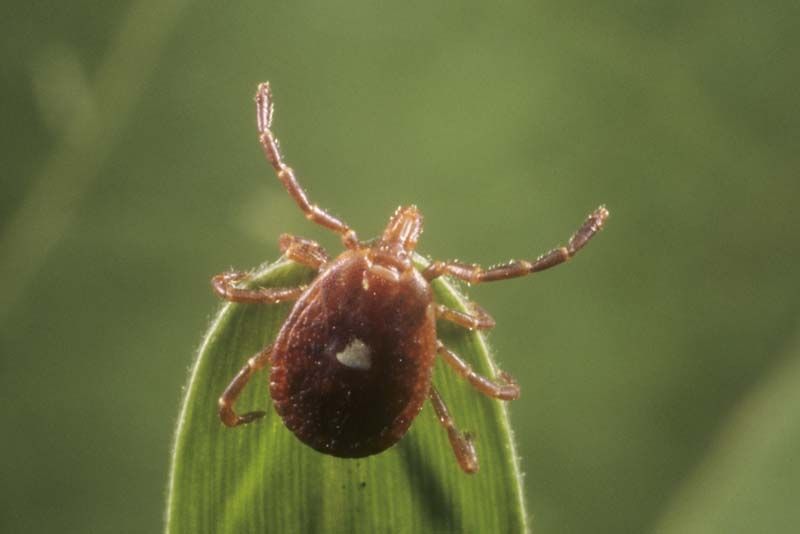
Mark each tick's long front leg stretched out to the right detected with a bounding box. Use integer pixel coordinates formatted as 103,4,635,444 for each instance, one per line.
422,206,608,284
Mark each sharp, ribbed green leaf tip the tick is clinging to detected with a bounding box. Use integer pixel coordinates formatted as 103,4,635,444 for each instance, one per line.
166,260,527,534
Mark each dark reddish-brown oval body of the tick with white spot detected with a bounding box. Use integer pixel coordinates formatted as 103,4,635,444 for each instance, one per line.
270,251,436,457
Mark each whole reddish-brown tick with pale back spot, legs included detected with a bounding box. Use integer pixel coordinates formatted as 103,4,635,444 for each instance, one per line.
212,83,608,473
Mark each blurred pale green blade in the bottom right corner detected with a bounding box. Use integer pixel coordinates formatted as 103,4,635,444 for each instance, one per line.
655,330,800,534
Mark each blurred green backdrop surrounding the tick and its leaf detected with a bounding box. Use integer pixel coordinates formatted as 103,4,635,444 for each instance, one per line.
0,0,800,533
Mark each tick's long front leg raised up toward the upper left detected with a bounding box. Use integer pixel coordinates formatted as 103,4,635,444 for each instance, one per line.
256,82,358,249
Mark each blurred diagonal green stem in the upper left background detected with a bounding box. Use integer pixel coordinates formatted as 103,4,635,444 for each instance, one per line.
0,0,187,320
